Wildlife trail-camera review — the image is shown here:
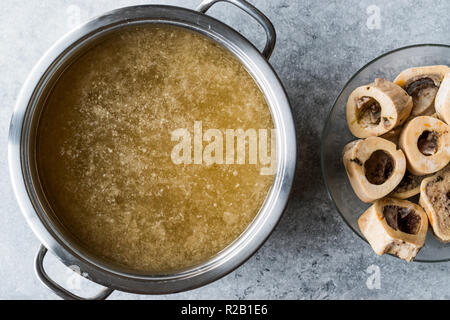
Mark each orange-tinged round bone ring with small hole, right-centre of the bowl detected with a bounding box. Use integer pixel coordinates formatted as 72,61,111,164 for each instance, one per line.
399,116,450,176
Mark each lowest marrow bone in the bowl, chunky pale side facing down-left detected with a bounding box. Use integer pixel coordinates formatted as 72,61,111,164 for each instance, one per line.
358,198,428,261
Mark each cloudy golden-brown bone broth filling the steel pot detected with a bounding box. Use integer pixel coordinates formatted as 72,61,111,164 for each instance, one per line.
36,25,274,273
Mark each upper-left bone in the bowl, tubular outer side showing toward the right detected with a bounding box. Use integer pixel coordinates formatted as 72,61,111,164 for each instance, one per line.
347,78,413,138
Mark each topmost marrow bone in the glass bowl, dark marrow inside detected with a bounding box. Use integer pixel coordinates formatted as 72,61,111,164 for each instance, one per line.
394,66,450,116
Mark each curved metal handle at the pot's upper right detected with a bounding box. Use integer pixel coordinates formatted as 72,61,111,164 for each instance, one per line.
197,0,277,60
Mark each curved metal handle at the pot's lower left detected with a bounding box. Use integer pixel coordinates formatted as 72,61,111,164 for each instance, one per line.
34,245,114,300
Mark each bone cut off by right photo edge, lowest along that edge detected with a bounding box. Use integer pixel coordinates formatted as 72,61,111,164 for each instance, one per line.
419,165,450,242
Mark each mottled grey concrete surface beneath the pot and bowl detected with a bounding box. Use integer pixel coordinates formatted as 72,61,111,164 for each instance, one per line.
0,0,450,299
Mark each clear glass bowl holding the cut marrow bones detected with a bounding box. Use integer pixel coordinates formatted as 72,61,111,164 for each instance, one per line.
321,44,450,262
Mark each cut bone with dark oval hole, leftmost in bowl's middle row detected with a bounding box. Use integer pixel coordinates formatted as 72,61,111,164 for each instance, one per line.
343,137,406,202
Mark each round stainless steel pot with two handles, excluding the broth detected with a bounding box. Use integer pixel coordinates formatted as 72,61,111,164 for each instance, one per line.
8,0,296,299
